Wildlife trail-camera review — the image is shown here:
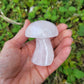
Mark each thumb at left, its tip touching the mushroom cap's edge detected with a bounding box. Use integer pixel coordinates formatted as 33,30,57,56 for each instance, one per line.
11,20,30,47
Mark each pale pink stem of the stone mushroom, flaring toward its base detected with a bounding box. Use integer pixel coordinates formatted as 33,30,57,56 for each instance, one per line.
32,38,54,66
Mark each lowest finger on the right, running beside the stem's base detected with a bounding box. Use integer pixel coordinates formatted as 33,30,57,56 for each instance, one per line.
48,46,71,74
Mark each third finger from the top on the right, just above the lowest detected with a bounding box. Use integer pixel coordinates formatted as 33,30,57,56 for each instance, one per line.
54,37,73,56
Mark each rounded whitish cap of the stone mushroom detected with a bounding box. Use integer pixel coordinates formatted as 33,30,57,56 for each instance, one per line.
25,20,58,38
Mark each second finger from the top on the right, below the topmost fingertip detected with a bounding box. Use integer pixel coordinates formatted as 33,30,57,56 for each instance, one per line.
52,29,72,48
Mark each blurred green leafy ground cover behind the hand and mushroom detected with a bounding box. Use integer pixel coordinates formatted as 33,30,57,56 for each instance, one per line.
0,0,84,84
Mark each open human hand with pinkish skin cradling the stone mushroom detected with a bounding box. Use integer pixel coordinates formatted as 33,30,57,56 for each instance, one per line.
0,20,73,84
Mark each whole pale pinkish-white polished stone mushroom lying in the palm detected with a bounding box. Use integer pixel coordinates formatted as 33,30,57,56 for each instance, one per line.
25,20,58,66
